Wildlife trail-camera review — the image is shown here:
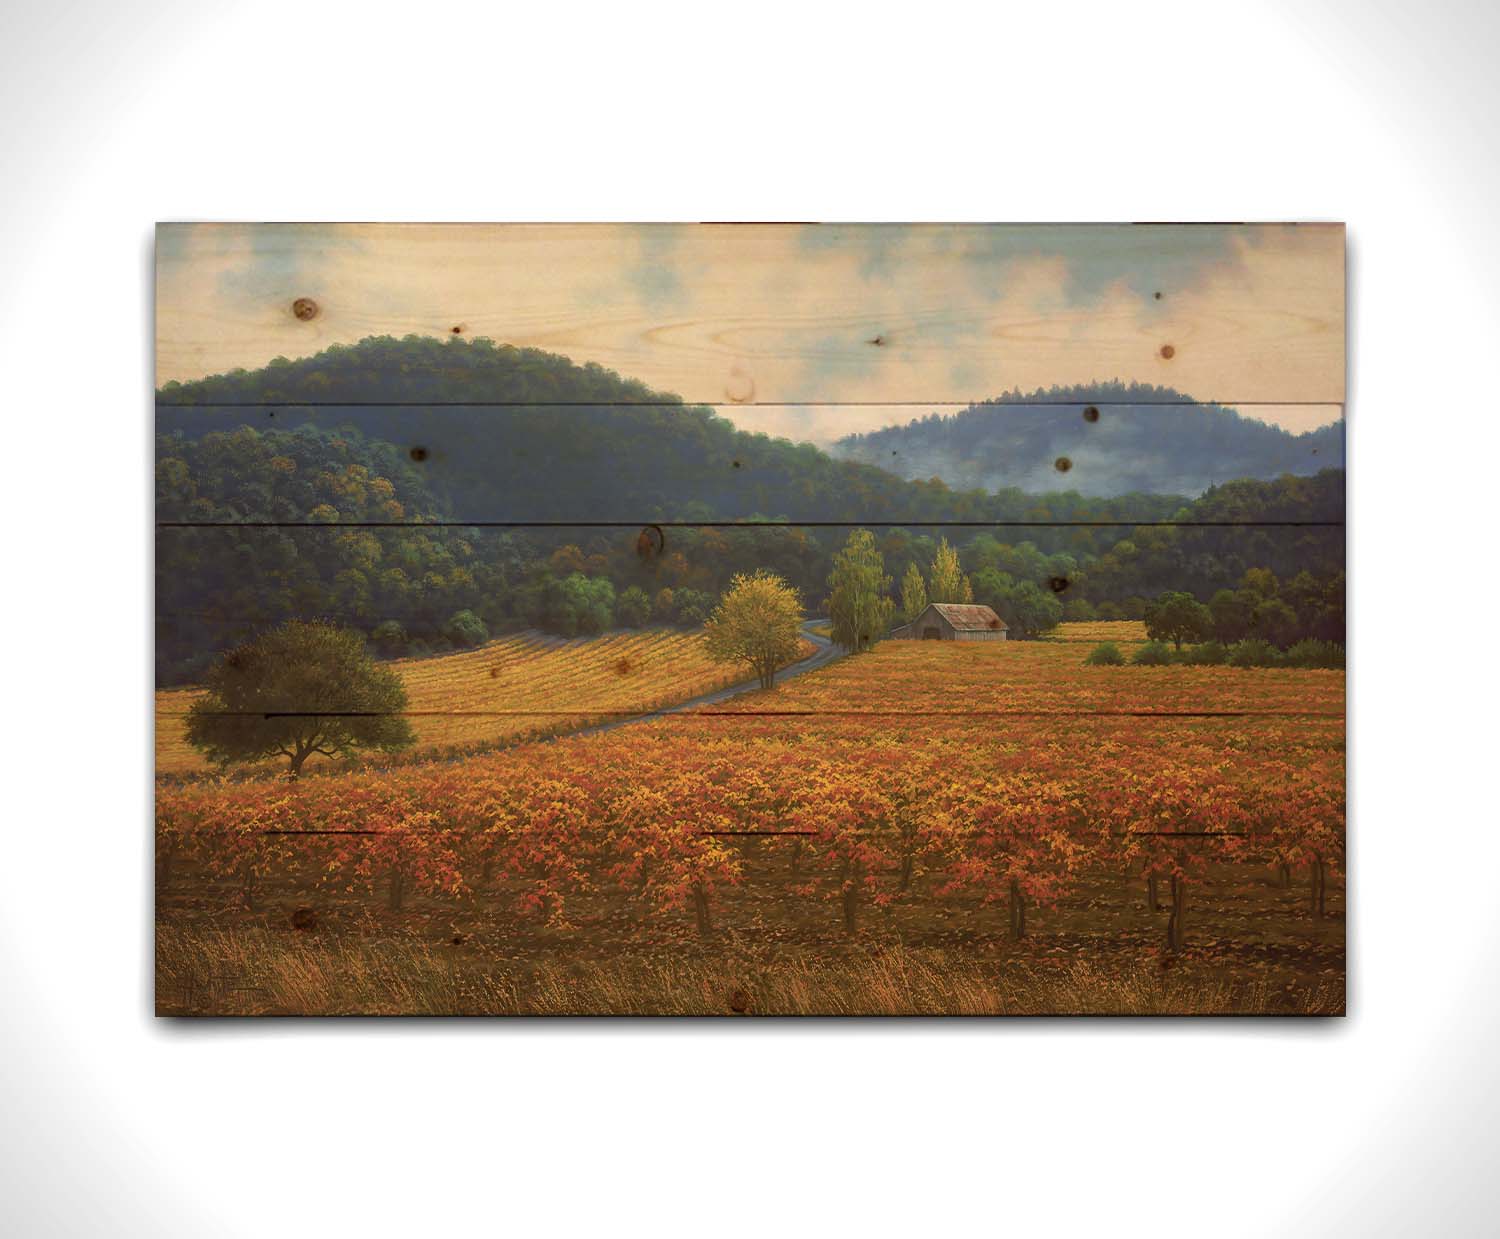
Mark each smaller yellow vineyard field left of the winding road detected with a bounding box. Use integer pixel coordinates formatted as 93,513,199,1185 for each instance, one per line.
156,629,813,774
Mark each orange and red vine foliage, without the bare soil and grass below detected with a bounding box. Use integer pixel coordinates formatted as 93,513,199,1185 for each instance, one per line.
158,642,1344,932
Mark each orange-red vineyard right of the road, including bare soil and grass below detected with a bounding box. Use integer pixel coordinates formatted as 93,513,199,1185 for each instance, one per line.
158,627,1344,1014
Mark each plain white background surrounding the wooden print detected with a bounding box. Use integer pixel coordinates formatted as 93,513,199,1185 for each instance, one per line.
0,0,1500,1236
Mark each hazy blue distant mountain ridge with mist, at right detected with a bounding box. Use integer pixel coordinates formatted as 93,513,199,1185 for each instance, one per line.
830,383,1344,497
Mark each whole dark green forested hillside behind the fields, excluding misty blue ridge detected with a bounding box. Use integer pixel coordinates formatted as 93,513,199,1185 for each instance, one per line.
156,338,1344,684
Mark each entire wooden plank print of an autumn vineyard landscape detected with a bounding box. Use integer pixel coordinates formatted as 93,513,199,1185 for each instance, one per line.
156,224,1347,1019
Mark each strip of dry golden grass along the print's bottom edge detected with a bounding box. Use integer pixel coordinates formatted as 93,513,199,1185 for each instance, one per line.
156,926,1344,1016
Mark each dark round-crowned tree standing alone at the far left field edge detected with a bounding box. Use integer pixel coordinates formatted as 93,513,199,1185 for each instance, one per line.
188,620,416,779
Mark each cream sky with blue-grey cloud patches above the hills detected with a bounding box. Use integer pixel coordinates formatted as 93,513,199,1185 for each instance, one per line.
156,224,1344,443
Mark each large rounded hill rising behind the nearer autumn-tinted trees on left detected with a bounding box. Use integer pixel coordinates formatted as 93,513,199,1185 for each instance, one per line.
156,336,1184,525
